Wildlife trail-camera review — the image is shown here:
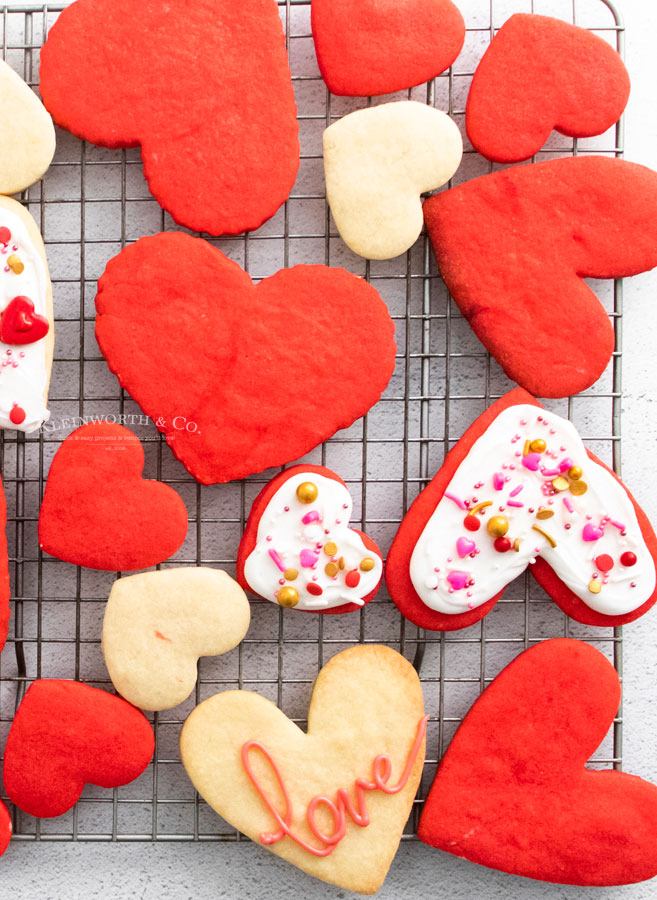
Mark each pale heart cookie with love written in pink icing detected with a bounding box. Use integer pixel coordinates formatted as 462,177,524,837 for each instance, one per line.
180,645,428,894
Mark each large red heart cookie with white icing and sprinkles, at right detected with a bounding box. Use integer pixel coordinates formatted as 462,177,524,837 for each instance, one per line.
386,388,657,631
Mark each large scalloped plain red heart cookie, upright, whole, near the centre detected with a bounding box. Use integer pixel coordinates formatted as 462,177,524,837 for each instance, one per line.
96,232,395,484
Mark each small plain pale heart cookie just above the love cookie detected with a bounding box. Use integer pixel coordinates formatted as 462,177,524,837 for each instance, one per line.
102,567,250,710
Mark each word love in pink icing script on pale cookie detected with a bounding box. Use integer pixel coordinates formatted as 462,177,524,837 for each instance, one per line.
242,716,429,856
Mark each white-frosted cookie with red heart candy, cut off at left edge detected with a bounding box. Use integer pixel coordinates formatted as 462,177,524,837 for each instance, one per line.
0,197,55,432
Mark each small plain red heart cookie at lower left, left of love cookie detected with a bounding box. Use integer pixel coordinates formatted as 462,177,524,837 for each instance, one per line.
4,680,155,818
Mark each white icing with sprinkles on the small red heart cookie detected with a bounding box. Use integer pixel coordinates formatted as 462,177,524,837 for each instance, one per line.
244,472,383,610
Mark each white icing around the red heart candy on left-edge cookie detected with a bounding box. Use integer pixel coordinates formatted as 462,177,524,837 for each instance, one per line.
0,207,50,432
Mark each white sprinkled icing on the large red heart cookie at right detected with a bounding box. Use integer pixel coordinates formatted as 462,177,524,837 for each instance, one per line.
410,405,656,616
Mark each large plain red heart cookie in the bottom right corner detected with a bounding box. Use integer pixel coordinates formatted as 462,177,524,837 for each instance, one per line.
418,639,657,885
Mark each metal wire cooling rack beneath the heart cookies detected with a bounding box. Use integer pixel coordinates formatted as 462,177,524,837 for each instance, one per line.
0,0,623,841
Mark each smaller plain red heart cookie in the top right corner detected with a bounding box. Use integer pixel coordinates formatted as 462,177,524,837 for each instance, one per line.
465,13,630,163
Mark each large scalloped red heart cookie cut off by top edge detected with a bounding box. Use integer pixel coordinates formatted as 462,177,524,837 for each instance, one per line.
40,0,299,234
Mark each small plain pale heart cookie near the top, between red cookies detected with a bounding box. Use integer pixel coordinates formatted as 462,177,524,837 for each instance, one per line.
324,100,463,259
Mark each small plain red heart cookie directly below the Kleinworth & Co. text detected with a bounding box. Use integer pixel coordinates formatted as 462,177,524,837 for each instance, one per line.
39,422,187,572
